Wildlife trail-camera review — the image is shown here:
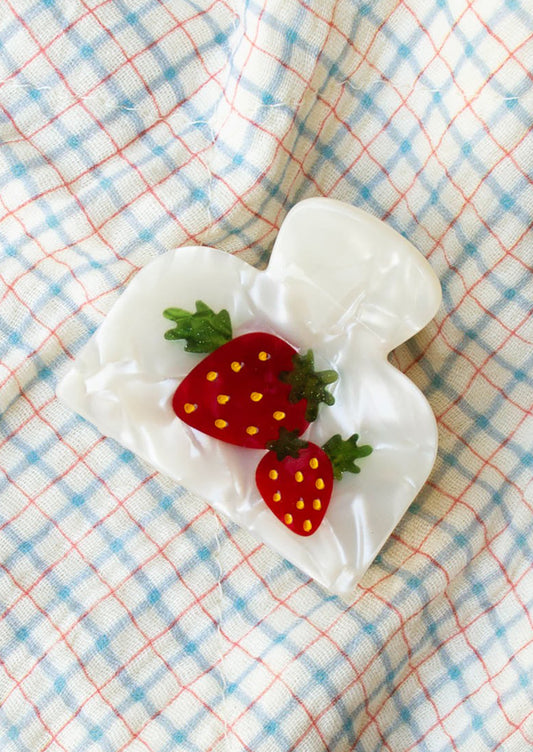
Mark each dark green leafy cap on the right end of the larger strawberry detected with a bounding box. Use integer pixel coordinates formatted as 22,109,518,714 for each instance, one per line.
279,350,338,423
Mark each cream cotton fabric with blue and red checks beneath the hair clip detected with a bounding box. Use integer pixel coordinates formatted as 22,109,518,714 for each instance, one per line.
0,0,533,752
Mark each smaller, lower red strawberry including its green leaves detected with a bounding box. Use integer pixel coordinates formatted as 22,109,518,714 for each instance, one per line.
255,430,372,536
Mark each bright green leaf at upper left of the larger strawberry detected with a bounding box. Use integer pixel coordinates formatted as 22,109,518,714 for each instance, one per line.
163,300,233,352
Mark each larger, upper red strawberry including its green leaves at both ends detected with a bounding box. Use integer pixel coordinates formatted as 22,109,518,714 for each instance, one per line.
163,301,337,449
